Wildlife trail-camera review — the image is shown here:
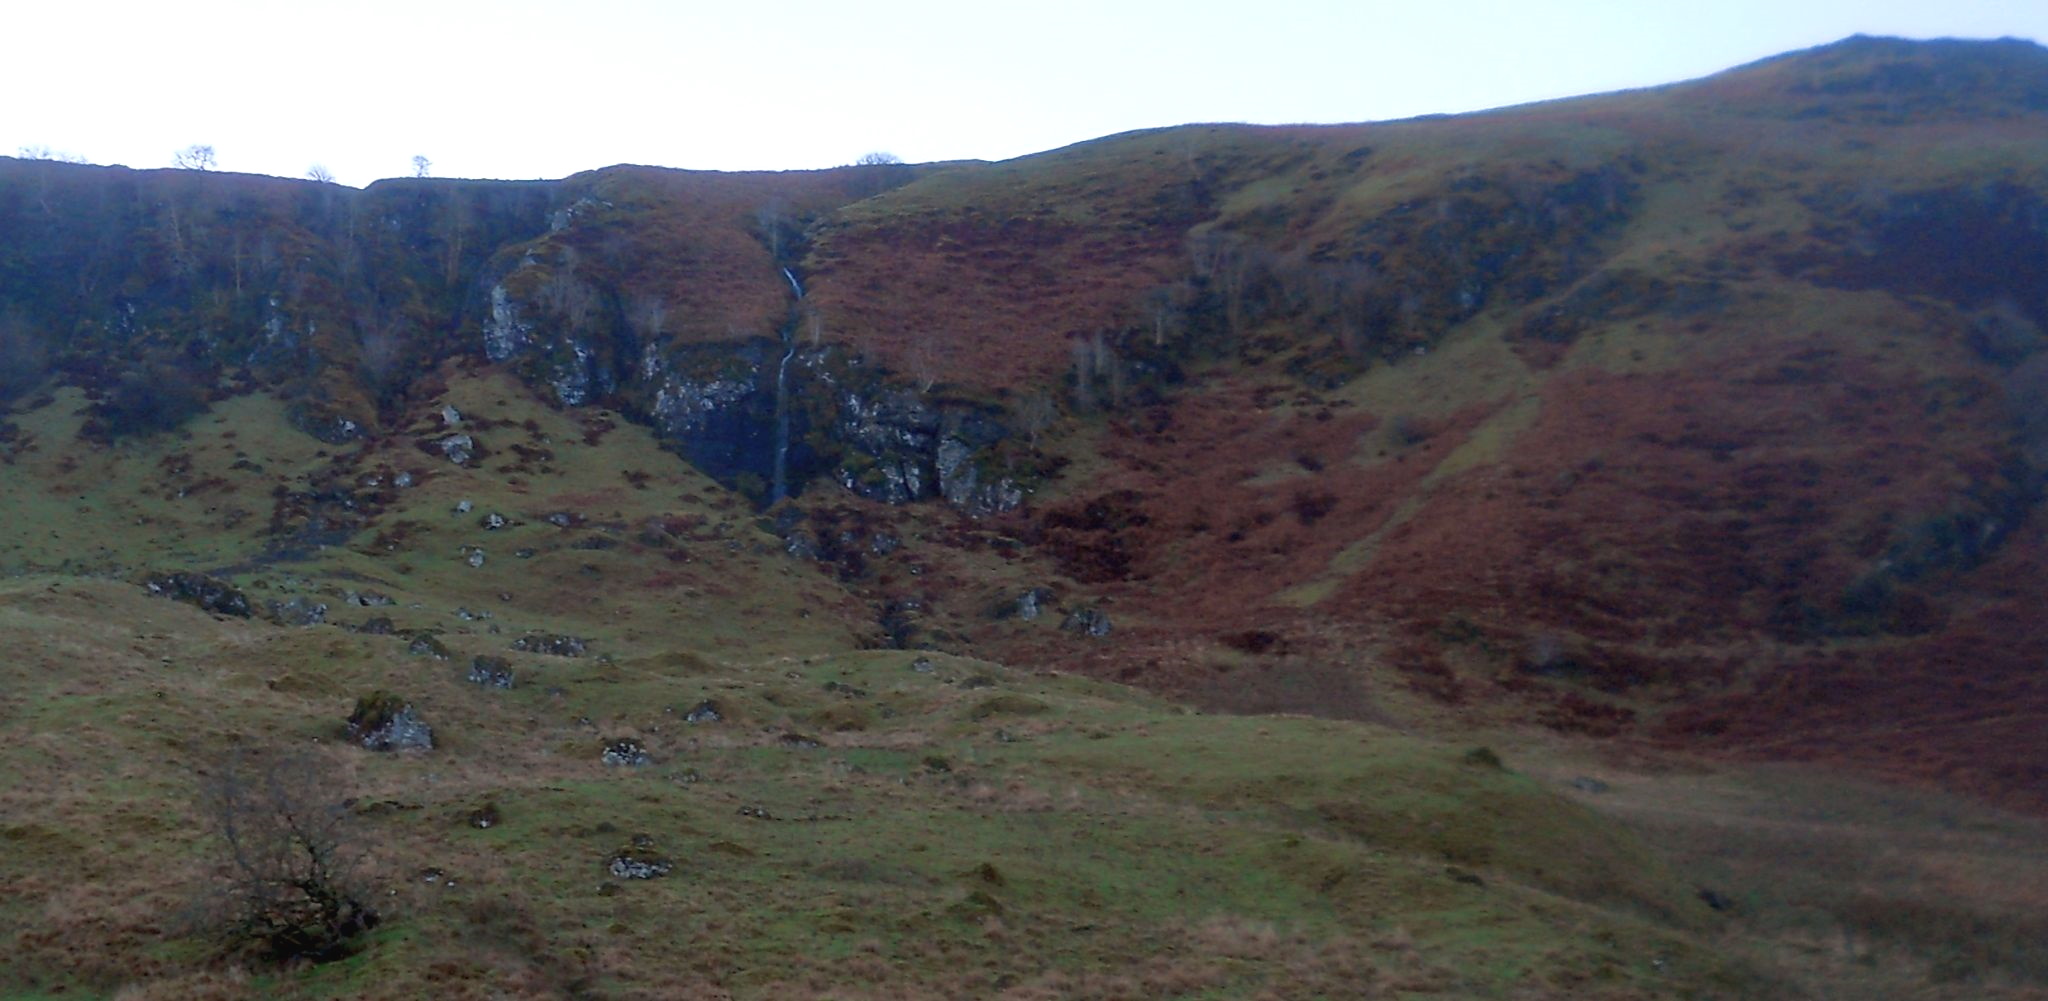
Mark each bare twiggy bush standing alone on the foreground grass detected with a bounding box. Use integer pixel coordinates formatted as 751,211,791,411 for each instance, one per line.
201,753,377,962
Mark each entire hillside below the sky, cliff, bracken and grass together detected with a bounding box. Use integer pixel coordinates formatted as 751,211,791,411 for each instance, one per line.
0,37,2048,1001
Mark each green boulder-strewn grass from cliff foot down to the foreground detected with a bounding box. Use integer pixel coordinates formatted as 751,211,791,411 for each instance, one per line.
0,373,2032,999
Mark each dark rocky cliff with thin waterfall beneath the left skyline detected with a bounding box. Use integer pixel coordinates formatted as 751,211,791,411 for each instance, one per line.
0,160,1022,512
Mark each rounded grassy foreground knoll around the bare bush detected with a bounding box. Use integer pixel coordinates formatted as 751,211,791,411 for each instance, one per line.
0,560,1751,997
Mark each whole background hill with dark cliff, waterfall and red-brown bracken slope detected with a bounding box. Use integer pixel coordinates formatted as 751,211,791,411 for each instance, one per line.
12,39,2048,806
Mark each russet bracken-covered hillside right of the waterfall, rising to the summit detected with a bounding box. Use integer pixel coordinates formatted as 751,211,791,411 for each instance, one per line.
786,41,2048,807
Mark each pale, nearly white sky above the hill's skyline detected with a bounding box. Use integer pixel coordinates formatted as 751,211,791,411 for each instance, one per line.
0,0,2048,184
